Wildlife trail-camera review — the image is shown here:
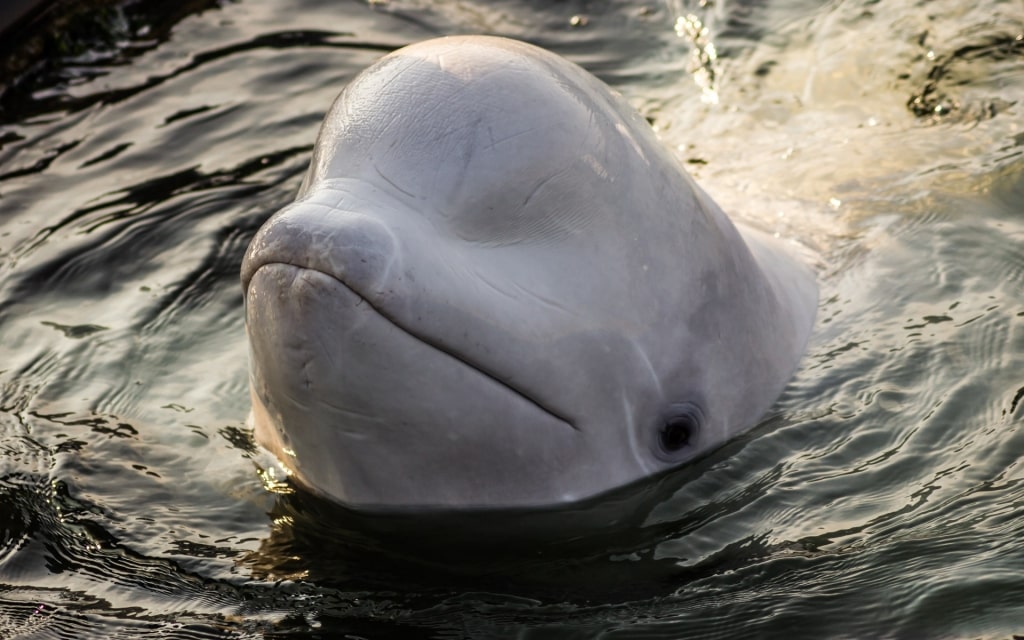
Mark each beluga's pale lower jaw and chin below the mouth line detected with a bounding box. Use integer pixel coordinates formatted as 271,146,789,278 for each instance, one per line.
246,263,622,511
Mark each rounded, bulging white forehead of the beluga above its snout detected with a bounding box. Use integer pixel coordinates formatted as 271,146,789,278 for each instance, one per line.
307,38,639,244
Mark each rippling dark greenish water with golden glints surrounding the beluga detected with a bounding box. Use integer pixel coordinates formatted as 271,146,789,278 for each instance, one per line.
0,0,1024,638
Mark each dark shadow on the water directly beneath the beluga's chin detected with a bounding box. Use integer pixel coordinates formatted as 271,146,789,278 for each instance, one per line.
241,438,761,603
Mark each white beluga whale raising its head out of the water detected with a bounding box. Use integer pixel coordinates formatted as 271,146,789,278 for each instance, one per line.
242,36,817,512
